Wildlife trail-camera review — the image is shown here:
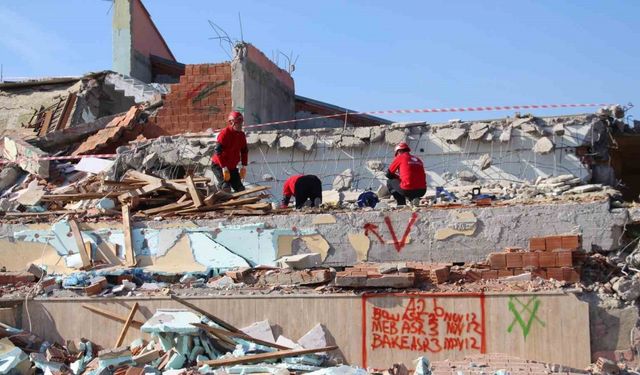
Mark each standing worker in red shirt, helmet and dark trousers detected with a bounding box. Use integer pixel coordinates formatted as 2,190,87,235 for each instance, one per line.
211,111,249,191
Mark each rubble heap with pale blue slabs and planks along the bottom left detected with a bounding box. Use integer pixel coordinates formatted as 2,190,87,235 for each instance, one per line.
0,296,356,375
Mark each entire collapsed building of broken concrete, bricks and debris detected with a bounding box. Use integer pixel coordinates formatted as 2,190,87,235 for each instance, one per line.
0,0,640,373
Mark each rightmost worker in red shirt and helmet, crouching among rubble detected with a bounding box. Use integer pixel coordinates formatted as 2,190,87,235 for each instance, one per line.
387,142,427,206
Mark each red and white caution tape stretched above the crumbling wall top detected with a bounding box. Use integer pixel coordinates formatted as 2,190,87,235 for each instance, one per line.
245,103,611,129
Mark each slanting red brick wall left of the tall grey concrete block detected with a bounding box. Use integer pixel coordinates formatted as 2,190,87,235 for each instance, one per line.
144,63,232,138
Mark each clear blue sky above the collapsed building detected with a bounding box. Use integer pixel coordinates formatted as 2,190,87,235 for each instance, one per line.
0,0,640,122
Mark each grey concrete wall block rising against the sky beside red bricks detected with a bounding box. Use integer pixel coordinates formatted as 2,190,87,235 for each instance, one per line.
231,43,295,129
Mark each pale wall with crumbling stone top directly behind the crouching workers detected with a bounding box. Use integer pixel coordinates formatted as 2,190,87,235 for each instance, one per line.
242,116,599,191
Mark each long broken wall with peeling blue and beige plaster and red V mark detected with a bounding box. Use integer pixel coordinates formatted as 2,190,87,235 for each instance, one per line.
0,200,629,272
